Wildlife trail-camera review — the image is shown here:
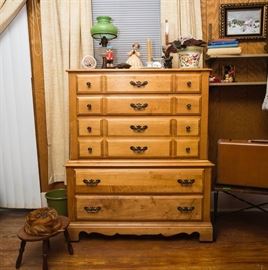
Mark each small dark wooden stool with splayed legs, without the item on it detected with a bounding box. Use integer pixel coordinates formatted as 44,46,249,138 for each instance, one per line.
16,216,73,270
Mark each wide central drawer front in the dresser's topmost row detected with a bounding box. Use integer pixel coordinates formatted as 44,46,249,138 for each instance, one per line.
106,74,172,93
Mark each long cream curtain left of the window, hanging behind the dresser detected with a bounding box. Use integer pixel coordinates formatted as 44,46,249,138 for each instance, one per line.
40,0,93,183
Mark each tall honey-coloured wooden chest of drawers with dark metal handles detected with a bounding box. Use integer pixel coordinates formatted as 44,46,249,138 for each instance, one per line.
66,69,212,241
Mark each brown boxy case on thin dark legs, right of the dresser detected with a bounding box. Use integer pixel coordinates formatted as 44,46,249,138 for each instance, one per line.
217,139,268,188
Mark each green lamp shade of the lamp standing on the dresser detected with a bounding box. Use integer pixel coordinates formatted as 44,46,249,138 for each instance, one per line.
90,16,117,40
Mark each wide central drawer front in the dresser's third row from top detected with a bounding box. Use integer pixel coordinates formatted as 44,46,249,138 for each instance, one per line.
107,117,171,137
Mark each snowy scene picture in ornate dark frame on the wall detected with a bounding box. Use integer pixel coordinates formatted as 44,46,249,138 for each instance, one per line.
220,2,268,39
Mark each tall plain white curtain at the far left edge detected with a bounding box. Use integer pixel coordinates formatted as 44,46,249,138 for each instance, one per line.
0,7,41,208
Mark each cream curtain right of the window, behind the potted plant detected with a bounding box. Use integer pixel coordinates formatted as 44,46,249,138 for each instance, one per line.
161,0,202,67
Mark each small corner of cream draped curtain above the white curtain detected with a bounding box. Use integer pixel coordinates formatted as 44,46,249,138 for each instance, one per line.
0,0,26,34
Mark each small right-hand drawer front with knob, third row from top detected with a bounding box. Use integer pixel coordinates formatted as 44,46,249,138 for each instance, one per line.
176,117,200,136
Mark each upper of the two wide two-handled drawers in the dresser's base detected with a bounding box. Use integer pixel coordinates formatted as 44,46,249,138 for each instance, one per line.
75,168,204,194
